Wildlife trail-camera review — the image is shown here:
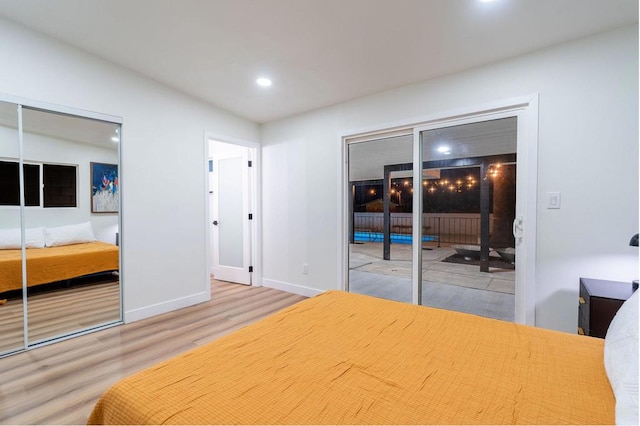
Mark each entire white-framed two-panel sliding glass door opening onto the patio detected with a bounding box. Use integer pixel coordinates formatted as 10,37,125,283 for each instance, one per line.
341,96,537,325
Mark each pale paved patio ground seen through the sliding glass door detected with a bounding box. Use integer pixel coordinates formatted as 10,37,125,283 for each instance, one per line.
349,243,515,321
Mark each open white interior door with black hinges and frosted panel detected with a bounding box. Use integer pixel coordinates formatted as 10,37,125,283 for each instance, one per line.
209,141,251,284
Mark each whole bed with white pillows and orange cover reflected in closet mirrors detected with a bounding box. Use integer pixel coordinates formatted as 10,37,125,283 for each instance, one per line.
0,223,119,293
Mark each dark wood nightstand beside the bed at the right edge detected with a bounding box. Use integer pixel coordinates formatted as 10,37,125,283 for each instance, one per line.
578,278,633,338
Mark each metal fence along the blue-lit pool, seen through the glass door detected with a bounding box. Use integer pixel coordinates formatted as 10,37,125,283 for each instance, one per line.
353,213,482,247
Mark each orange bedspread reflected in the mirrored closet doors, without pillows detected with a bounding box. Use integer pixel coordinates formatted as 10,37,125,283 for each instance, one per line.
0,241,119,293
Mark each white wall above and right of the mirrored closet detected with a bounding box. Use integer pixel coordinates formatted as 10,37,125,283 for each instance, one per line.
0,20,259,321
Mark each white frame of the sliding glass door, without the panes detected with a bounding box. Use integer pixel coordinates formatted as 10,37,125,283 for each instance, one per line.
337,94,538,325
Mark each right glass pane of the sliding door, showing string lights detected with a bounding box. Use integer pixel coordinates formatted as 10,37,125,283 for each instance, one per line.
417,117,517,321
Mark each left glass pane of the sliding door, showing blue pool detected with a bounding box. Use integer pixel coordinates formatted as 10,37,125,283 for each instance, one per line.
348,135,414,302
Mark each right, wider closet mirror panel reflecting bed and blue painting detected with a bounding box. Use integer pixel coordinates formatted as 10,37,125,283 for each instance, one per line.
22,107,121,345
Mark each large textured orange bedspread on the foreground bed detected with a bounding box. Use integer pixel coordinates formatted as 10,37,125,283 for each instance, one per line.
89,291,615,424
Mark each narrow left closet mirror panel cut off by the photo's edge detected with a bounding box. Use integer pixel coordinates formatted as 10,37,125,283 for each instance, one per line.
0,102,25,355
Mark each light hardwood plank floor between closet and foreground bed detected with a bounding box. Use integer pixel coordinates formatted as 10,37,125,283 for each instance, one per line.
0,279,304,424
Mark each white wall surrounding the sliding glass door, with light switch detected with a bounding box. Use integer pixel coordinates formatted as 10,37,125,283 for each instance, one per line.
262,26,638,332
